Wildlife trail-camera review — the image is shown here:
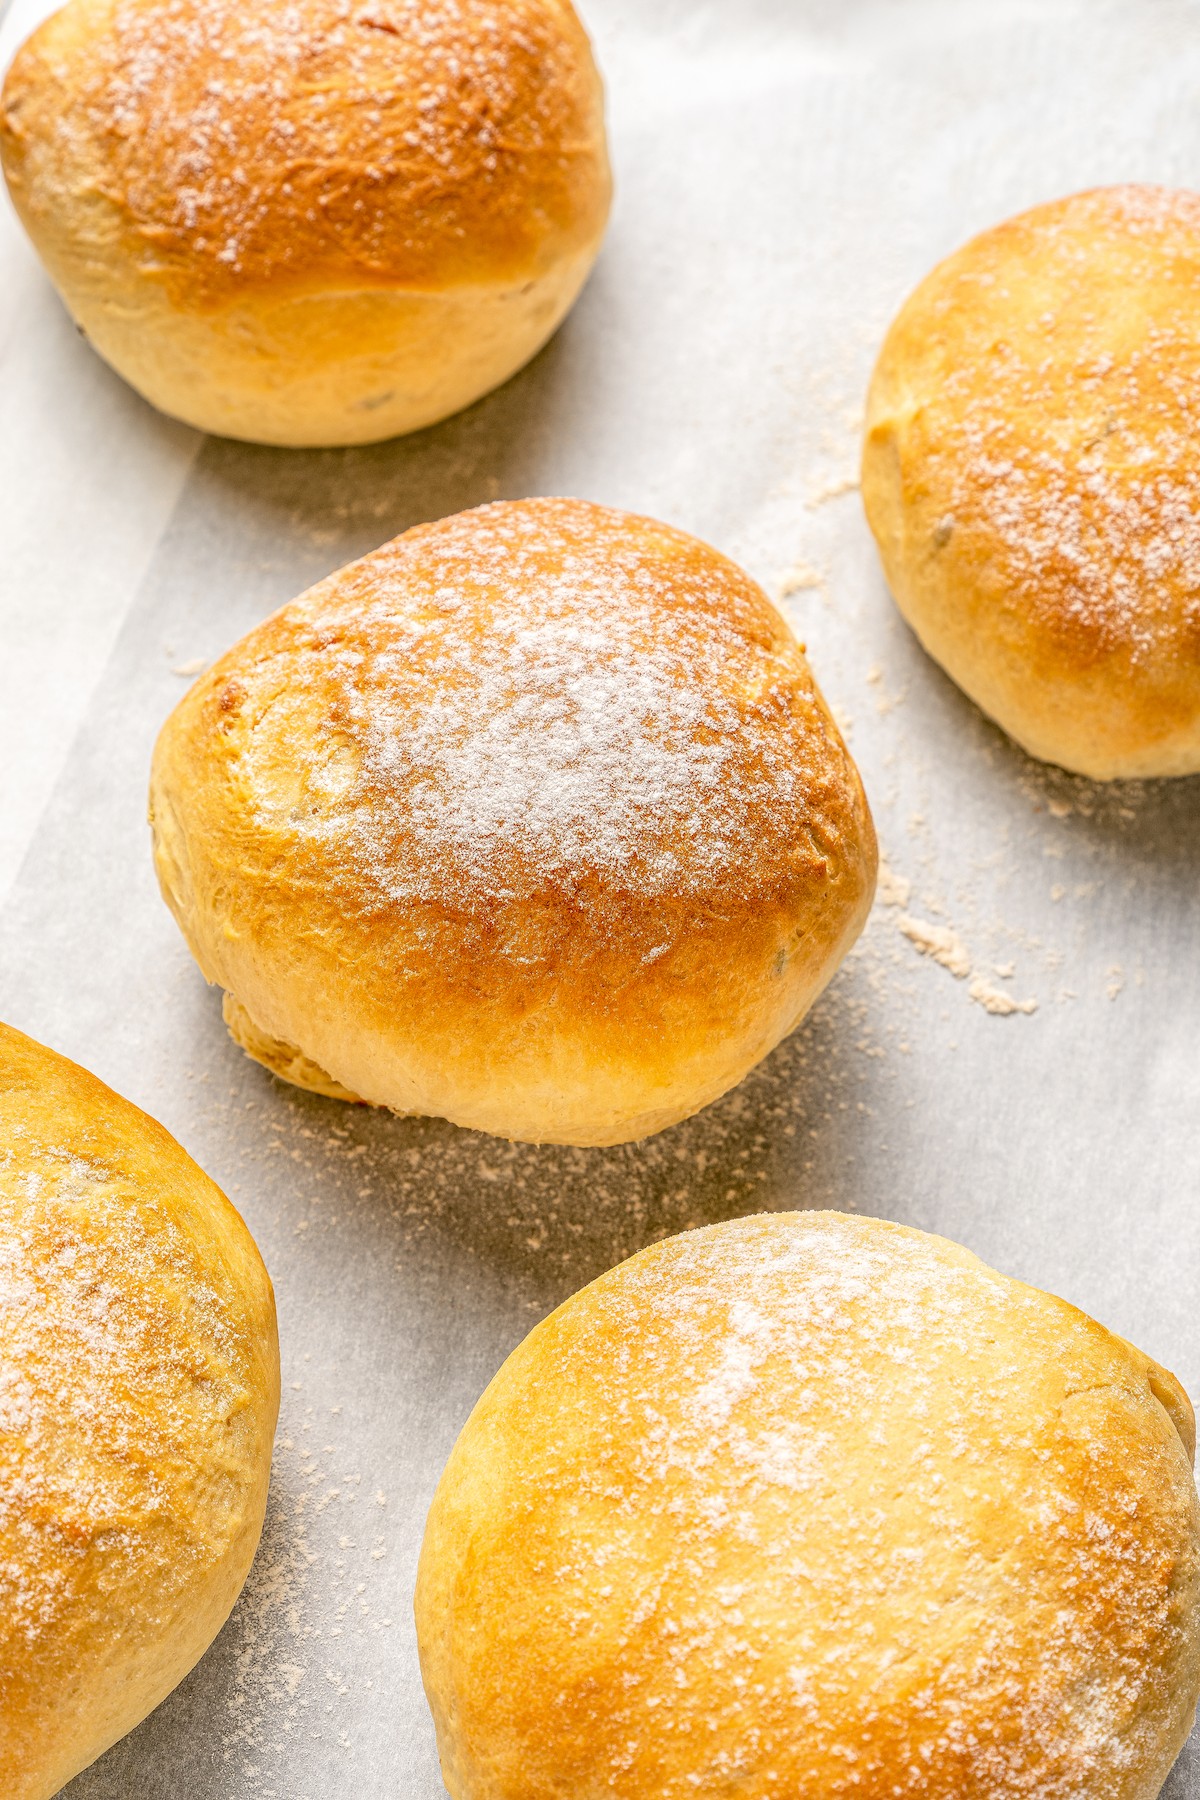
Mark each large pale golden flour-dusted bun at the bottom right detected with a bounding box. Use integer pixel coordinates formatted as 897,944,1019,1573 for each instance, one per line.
416,1213,1200,1800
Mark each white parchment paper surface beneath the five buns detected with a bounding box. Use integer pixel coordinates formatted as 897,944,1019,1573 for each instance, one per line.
0,0,1200,1800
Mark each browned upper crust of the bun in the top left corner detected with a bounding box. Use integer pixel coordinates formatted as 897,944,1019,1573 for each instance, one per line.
0,0,610,310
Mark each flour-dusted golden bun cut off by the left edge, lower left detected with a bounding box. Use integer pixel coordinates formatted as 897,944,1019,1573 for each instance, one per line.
0,1026,279,1800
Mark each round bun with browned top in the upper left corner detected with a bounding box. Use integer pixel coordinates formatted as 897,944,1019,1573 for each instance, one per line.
0,0,610,445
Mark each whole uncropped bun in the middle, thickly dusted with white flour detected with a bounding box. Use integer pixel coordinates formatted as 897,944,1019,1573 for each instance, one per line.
151,500,876,1143
